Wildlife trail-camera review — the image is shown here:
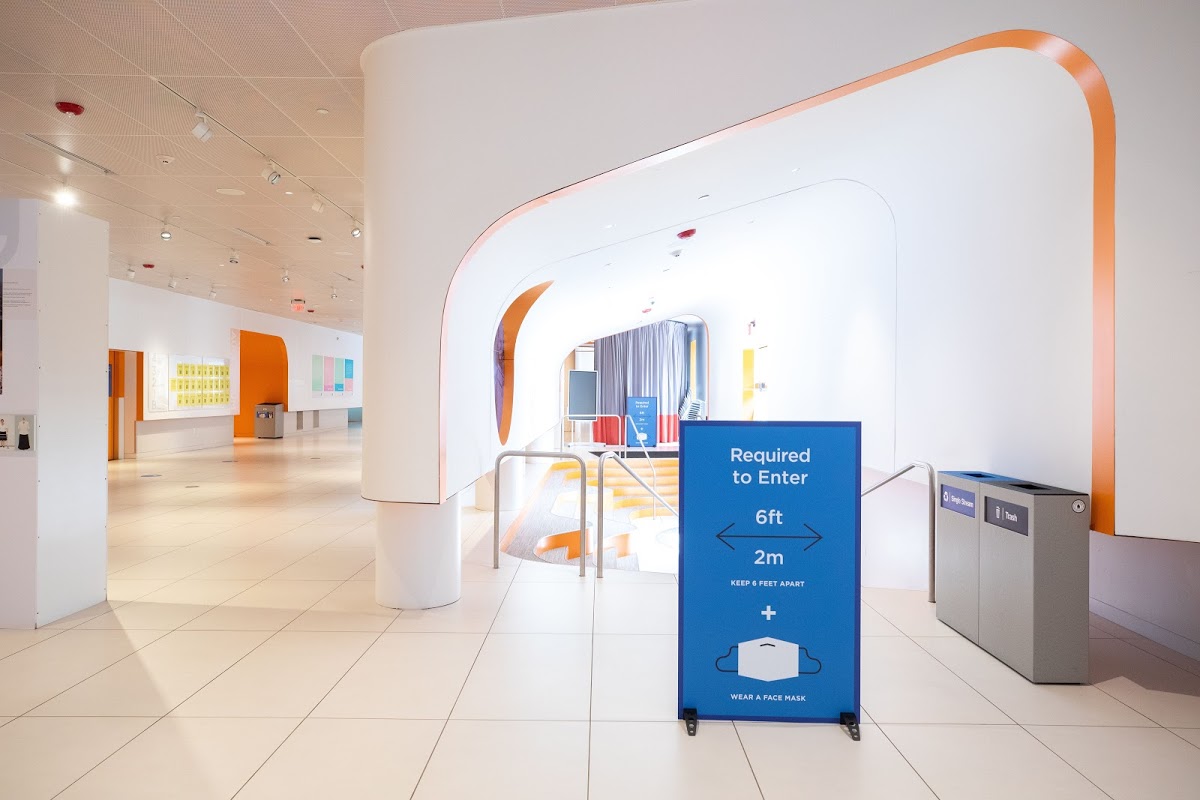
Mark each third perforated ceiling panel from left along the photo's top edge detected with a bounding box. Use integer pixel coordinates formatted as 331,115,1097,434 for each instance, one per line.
160,0,333,78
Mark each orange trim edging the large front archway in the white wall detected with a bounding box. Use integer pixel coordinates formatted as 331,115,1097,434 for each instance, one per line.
438,30,1116,534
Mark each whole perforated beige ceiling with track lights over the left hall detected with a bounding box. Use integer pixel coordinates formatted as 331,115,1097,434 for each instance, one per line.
0,0,654,331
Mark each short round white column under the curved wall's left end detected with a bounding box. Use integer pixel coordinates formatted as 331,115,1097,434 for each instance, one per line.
376,494,462,609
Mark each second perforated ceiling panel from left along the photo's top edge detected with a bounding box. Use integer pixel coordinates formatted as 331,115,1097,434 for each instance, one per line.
43,0,235,76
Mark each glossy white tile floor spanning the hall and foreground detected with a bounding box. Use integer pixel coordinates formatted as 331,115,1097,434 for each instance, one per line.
0,432,1200,800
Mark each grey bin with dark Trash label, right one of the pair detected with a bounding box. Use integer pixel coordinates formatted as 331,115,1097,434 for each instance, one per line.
979,481,1091,684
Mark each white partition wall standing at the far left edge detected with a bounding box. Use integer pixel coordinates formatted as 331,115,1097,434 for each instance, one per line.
0,199,108,628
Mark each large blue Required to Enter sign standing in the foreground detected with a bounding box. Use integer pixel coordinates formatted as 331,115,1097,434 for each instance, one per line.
679,421,862,722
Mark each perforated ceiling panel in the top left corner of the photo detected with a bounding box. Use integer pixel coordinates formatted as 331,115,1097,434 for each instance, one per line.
0,0,140,74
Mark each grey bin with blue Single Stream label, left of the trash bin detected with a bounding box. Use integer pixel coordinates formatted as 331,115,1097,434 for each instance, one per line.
935,471,1014,644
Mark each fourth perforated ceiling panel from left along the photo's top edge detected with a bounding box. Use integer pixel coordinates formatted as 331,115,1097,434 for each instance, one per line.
272,0,400,77
